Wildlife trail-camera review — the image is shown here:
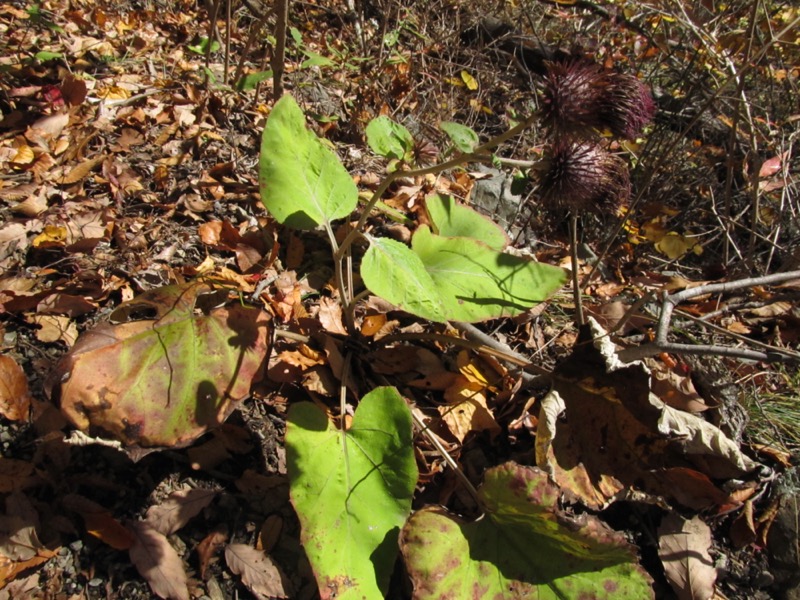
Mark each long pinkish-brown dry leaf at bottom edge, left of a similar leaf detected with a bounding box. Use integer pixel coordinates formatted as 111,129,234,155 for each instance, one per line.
128,521,189,600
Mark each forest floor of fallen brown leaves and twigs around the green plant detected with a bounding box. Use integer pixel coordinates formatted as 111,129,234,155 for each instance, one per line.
0,0,800,600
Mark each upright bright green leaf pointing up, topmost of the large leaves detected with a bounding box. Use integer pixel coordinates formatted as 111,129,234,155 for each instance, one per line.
258,96,358,229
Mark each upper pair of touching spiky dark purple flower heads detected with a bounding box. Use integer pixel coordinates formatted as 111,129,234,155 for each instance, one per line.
542,58,655,139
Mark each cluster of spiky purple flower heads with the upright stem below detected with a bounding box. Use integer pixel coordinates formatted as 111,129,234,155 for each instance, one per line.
536,58,655,325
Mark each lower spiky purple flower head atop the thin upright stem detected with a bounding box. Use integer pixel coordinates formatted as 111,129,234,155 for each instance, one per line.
539,141,631,214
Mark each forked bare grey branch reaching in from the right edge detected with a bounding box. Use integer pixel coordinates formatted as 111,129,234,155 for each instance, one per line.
618,271,800,362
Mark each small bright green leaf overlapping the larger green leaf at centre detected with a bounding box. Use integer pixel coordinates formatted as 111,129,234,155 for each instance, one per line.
361,238,447,322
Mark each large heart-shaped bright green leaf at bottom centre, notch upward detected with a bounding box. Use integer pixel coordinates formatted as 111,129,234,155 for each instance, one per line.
286,388,417,600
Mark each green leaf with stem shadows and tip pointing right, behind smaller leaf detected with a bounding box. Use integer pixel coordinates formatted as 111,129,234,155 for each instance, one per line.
410,226,565,322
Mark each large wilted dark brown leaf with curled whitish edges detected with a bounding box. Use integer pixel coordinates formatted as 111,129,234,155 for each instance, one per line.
537,319,759,508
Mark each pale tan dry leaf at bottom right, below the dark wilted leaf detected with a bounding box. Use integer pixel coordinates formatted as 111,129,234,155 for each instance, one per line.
658,512,717,600
